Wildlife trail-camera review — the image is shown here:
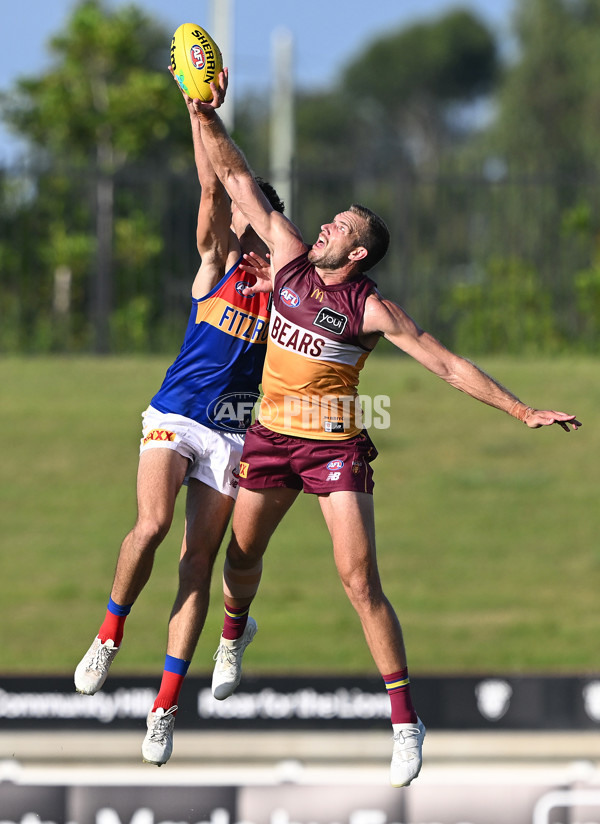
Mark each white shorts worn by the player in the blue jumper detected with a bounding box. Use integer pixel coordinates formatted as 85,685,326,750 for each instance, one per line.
140,406,244,499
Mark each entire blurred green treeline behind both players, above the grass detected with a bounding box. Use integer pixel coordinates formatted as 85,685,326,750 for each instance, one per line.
0,0,600,352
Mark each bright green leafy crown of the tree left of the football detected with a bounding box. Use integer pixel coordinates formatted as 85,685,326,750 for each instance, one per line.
5,0,188,166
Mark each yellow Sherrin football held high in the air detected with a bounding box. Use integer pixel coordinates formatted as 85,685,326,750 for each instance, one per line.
171,23,223,100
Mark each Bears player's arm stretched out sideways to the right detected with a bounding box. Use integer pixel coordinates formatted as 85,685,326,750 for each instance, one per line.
363,295,581,432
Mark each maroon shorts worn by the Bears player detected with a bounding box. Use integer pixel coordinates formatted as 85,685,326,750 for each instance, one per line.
240,423,377,495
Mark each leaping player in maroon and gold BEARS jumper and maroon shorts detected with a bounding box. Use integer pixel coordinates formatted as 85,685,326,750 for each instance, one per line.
194,67,580,786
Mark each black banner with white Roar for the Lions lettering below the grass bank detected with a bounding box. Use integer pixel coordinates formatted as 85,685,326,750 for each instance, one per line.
0,676,600,731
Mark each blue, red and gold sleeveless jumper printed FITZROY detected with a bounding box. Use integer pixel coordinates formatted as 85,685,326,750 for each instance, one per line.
150,258,271,432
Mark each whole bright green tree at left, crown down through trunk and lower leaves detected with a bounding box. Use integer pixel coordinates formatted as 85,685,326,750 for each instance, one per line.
4,0,197,351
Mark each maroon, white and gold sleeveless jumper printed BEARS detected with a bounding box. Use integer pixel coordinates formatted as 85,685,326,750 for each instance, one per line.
259,253,376,440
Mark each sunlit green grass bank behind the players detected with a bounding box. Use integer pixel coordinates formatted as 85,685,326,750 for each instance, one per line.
0,354,600,674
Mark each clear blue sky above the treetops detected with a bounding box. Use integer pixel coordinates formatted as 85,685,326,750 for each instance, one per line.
0,0,518,163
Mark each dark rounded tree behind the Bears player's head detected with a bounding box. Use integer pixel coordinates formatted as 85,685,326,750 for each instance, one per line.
297,11,499,322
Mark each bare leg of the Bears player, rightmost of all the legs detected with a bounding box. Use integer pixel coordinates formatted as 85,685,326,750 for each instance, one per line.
319,492,406,675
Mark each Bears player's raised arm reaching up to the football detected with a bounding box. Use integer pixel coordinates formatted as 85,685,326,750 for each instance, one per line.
188,71,307,276
